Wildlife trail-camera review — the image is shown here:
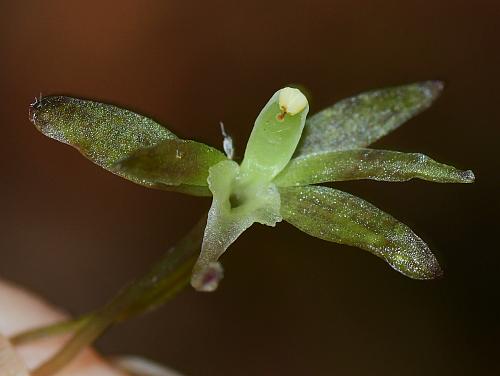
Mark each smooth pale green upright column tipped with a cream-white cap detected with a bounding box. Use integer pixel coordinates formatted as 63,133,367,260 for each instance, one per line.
241,88,309,181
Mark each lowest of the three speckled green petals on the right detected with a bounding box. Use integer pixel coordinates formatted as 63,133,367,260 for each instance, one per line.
280,186,442,279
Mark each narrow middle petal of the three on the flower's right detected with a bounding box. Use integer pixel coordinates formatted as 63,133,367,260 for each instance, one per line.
274,149,474,186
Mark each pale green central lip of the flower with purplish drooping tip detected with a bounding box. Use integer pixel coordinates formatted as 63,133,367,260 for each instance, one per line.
191,160,282,291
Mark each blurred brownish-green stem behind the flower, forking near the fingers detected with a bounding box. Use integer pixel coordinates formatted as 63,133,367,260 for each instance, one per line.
12,217,206,376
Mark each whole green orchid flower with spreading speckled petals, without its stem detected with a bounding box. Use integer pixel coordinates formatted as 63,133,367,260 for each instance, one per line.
30,81,474,291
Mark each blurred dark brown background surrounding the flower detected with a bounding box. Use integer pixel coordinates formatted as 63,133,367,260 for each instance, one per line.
0,0,500,376
